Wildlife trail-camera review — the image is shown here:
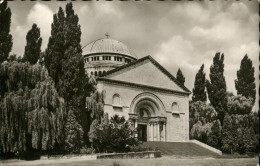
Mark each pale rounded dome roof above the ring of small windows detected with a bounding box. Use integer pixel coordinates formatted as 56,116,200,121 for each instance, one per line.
82,38,137,59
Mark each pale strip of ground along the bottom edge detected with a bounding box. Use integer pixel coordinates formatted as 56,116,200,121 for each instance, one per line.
0,156,258,166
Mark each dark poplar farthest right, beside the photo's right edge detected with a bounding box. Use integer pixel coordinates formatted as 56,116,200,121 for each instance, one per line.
235,55,256,103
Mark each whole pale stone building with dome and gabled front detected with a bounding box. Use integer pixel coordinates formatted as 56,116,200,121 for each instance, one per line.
83,38,191,142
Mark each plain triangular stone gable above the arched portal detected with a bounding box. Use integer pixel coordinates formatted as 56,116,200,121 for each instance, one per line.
105,58,187,92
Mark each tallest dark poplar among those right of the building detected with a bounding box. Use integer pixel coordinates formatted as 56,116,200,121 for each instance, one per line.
206,52,227,123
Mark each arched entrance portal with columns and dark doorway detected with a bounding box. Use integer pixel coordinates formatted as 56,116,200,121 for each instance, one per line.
129,93,166,142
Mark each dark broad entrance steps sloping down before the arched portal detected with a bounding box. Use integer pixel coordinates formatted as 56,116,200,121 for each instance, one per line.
141,142,220,157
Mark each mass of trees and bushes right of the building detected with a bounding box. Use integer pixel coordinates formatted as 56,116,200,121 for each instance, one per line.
190,53,259,154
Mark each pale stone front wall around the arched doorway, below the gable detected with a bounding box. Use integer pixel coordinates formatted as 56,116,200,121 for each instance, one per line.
98,82,189,142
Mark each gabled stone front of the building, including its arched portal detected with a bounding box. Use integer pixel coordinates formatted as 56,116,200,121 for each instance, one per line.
97,56,190,142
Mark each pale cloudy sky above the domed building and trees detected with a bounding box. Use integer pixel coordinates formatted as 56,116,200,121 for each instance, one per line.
8,0,259,109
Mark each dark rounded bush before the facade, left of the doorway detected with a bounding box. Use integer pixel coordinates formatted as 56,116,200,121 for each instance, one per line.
89,114,138,152
